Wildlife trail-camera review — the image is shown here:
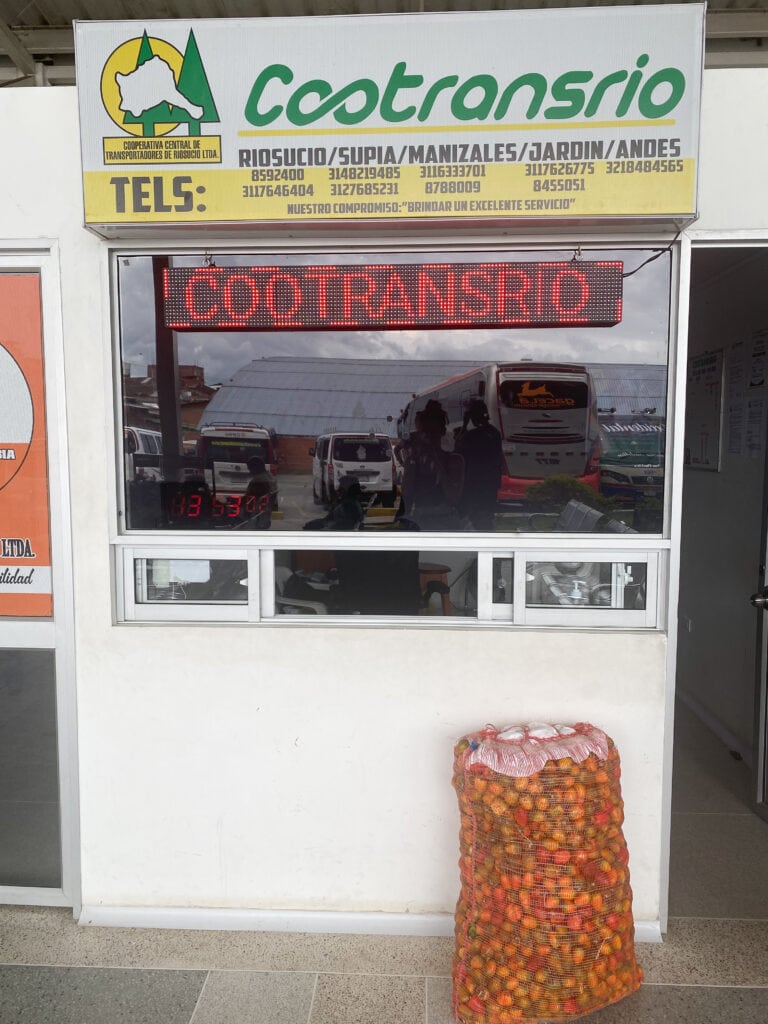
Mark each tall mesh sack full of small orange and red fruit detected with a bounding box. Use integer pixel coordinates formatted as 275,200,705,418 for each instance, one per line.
453,723,642,1024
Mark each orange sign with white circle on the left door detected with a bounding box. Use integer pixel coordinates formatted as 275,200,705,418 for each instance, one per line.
0,273,53,617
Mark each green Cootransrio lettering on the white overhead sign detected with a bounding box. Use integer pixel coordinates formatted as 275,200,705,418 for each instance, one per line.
245,53,686,128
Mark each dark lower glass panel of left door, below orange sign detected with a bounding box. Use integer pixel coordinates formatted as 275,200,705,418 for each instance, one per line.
0,650,61,889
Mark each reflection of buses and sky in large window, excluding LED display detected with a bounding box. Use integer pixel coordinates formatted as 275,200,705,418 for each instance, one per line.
118,249,672,543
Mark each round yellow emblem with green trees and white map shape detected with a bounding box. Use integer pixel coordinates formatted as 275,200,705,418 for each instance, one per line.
101,31,219,138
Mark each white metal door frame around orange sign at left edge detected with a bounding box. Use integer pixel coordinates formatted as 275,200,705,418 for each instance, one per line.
0,239,81,916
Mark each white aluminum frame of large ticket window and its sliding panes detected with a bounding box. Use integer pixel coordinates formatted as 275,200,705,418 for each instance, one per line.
108,234,684,631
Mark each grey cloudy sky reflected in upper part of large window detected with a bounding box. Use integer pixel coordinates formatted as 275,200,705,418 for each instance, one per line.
118,249,672,384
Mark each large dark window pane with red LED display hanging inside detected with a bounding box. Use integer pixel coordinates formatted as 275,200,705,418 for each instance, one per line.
116,248,672,544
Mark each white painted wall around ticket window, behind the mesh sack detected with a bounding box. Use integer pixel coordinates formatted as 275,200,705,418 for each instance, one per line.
16,66,768,922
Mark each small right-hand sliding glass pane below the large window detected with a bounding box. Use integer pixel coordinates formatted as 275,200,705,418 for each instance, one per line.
525,561,646,610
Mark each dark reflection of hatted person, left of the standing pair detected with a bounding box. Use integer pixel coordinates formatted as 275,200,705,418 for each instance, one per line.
402,398,466,530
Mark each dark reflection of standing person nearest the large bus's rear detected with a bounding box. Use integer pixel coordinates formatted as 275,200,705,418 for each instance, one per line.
455,398,504,534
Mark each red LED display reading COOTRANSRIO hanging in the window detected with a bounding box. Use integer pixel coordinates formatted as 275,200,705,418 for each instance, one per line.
164,260,624,331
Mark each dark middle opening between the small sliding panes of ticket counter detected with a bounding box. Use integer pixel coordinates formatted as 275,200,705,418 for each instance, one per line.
274,550,477,617
